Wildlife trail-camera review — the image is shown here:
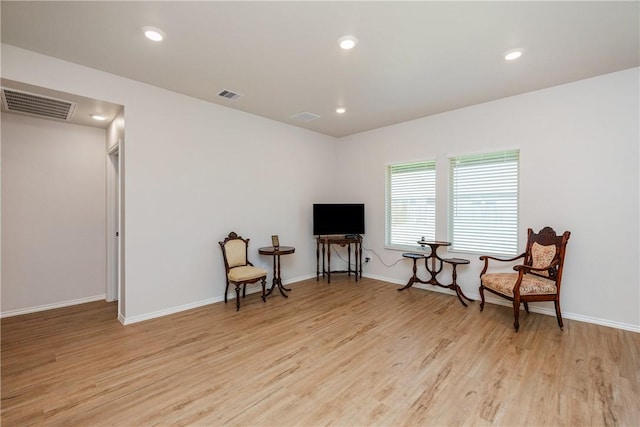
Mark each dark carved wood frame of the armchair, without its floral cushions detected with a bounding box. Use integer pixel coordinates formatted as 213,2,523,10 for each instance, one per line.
480,227,571,332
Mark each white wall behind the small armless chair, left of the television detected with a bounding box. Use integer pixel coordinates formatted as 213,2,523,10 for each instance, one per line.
2,44,336,322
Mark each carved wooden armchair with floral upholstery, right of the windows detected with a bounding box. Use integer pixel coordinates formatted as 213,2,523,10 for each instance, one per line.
480,227,571,332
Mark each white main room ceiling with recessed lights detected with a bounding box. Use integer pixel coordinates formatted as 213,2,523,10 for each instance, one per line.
1,1,640,137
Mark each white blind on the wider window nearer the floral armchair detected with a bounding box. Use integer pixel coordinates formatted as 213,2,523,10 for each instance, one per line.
449,150,519,255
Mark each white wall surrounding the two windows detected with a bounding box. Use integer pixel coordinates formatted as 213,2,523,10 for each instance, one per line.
336,68,640,331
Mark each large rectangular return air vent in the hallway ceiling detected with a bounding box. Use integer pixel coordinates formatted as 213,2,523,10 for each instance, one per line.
2,88,76,121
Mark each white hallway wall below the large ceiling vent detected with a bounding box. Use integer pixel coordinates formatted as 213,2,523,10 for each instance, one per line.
1,113,105,314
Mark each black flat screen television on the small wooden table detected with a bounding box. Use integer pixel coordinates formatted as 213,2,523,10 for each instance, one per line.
313,203,364,236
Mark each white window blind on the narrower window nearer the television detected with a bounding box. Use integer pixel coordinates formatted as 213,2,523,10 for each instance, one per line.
385,161,436,247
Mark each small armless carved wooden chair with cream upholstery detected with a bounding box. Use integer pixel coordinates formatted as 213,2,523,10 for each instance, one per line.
218,231,267,311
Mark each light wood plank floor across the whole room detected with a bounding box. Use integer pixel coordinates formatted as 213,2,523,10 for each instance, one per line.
2,276,640,427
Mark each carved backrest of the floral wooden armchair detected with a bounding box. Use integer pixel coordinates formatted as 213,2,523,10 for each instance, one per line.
524,227,571,287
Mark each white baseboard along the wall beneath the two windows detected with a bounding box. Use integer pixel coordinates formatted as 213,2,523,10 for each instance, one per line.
363,274,640,333
